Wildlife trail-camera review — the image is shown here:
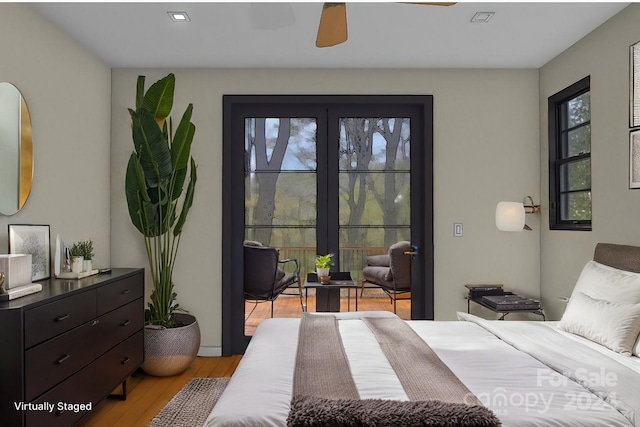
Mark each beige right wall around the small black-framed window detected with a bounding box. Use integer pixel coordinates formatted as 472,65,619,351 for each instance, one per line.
540,4,640,319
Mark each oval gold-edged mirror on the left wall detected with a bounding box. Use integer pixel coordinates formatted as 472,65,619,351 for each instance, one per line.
0,83,33,215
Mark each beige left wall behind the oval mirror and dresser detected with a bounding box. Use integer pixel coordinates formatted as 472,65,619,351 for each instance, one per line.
0,3,111,267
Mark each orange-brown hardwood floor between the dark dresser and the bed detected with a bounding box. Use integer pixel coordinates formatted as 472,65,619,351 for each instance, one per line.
80,355,242,427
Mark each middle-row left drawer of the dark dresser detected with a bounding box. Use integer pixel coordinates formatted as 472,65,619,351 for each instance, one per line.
25,322,99,401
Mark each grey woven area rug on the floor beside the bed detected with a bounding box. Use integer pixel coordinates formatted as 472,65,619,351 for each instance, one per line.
149,377,229,427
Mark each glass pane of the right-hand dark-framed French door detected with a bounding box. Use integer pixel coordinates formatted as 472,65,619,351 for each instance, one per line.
338,117,411,290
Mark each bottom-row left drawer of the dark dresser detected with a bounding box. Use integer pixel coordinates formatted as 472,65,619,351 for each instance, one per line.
26,363,98,427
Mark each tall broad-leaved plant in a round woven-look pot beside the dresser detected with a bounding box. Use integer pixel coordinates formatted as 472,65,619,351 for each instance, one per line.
125,74,200,376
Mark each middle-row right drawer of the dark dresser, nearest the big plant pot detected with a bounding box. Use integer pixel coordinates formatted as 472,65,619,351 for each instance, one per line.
96,298,144,356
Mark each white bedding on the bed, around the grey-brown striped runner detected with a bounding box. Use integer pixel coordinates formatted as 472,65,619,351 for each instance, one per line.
205,312,640,427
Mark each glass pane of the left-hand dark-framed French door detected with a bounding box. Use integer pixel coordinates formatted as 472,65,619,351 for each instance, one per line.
244,117,317,335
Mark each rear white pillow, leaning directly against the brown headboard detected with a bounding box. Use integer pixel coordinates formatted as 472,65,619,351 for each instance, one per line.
571,261,640,304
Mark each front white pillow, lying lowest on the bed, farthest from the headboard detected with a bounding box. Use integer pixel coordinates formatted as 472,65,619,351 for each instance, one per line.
558,292,640,356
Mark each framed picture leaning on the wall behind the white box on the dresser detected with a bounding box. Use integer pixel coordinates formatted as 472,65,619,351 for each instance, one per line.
9,224,51,282
